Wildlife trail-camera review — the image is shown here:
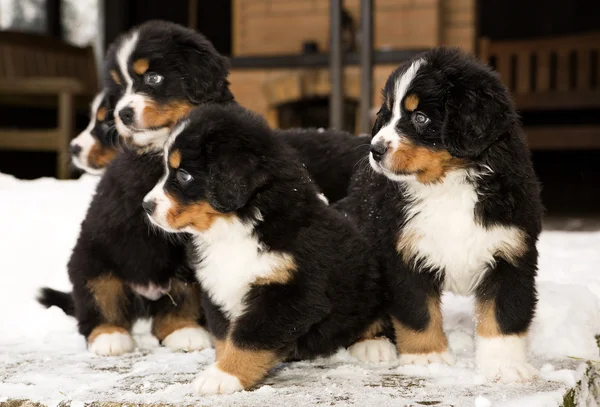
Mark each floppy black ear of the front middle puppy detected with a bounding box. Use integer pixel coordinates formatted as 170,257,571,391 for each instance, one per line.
207,156,269,213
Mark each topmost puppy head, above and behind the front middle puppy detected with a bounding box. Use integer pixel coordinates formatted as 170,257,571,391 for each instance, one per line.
105,21,233,151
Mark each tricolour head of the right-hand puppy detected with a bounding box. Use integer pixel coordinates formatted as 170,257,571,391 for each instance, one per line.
369,48,518,183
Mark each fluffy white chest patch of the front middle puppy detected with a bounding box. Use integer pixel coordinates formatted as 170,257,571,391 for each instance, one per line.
194,219,289,319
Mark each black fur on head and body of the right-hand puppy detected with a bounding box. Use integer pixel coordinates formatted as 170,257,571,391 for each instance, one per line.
335,48,543,348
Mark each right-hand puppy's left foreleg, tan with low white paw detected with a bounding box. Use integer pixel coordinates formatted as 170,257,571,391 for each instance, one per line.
392,284,454,365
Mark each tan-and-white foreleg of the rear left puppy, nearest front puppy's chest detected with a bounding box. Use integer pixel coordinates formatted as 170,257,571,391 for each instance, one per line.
152,280,211,352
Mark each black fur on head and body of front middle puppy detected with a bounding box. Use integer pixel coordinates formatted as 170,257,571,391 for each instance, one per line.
147,105,382,382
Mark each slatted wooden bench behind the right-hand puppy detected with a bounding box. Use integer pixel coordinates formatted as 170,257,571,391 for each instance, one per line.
479,32,600,149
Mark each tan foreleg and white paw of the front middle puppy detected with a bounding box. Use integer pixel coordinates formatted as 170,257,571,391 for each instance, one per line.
193,338,279,394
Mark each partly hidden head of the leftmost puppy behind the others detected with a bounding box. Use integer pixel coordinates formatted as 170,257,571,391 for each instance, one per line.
71,92,118,174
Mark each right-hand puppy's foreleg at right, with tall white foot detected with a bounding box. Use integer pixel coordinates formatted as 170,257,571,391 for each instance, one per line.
475,260,536,382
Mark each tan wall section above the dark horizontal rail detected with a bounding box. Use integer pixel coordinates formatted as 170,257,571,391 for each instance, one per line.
233,0,475,56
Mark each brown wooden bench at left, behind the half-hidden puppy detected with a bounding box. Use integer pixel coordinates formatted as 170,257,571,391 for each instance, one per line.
0,31,98,179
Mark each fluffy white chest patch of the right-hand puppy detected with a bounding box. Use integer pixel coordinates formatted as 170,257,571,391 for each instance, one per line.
397,170,524,295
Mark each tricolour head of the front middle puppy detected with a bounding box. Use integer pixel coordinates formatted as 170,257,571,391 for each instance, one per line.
143,105,277,233
